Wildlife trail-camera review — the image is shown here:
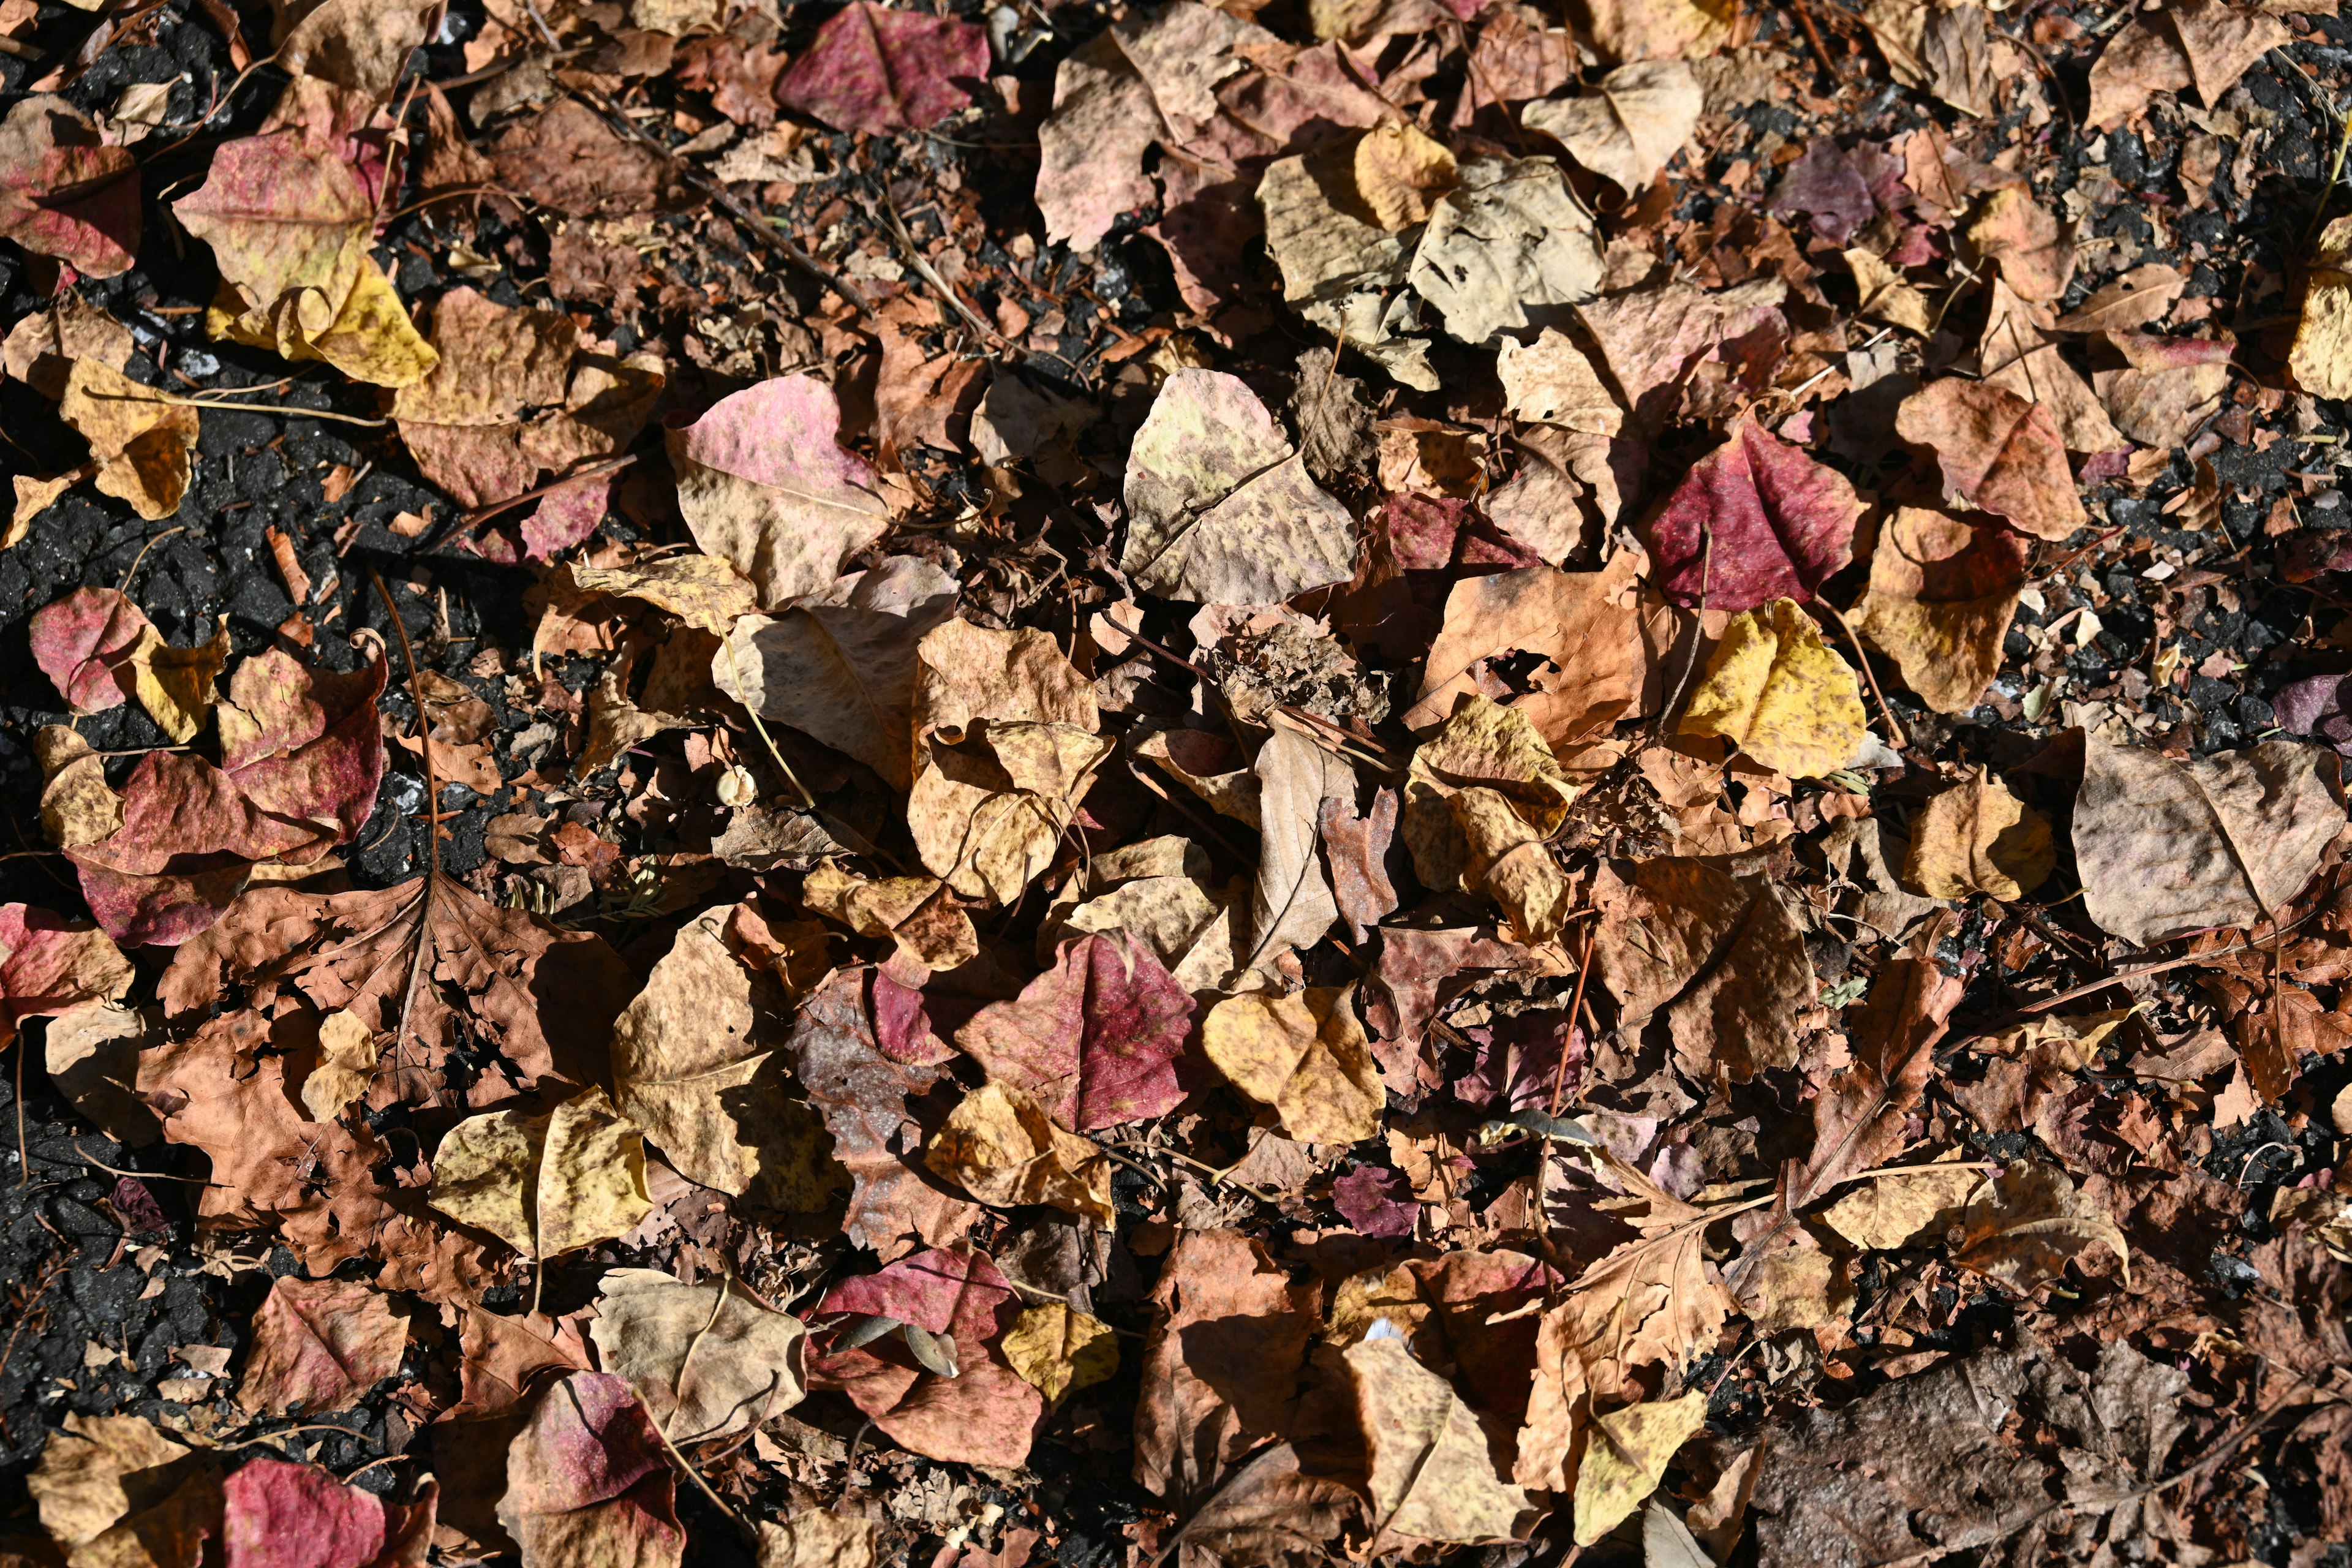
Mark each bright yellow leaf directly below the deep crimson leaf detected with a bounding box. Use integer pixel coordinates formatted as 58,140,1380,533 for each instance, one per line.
1682,600,1870,778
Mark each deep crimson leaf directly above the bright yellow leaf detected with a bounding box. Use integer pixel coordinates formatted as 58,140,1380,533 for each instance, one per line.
1649,416,1863,614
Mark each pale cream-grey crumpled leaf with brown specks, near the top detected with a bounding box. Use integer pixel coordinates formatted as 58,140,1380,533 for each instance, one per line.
1406,157,1602,343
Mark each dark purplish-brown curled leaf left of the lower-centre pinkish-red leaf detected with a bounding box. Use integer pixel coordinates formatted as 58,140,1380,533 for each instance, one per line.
786,971,981,1260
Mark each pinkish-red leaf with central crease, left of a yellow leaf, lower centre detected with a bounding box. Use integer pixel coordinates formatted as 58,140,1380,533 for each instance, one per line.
955,936,1193,1133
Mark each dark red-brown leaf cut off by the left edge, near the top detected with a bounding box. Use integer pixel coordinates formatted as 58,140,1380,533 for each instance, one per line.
0,92,139,277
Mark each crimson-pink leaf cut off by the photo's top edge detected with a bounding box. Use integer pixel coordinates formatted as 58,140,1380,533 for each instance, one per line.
776,0,988,137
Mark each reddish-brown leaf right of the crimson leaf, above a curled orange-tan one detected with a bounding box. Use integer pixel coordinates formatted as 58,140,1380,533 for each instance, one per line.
1896,376,2086,538
